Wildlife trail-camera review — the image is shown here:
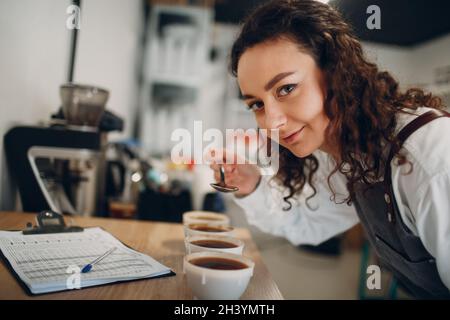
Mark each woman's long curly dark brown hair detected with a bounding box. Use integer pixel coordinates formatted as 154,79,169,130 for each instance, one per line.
230,0,444,210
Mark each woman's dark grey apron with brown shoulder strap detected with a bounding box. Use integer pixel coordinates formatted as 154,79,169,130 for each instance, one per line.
353,110,450,299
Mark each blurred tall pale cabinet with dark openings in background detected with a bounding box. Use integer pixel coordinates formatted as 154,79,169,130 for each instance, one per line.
139,5,213,155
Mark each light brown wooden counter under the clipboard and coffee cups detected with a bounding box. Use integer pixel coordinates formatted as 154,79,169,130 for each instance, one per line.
0,212,283,300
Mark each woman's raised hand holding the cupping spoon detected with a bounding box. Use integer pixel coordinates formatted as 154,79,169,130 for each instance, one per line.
210,151,261,197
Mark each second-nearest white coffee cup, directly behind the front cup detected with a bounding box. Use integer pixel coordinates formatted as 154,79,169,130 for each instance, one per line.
185,236,244,255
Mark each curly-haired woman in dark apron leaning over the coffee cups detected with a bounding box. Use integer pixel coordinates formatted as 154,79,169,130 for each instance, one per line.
211,0,450,298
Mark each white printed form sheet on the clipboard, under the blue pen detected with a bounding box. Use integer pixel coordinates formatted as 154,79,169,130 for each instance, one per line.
0,228,171,294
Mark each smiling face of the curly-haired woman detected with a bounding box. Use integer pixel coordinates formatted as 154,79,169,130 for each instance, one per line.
237,39,329,157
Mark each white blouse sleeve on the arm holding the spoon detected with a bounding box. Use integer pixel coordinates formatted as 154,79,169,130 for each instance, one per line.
235,151,359,245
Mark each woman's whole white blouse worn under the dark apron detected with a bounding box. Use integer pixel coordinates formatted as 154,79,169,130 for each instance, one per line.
234,107,450,288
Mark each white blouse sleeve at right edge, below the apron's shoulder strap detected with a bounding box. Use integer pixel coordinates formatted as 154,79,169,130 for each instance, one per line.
391,118,450,289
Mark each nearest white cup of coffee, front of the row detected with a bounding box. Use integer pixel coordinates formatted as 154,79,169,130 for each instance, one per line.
184,251,255,300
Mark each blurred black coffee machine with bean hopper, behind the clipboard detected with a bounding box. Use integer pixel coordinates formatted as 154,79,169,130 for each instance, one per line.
4,83,123,215
